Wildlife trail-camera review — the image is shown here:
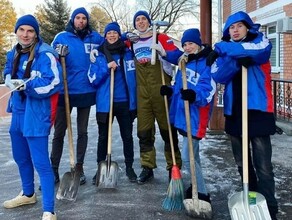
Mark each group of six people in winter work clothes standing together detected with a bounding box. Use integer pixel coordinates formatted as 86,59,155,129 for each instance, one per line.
3,5,278,220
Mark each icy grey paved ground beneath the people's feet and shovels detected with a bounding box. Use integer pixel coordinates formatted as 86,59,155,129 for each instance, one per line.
0,111,292,220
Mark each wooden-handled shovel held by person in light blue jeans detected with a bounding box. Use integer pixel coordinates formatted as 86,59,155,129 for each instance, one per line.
181,60,212,219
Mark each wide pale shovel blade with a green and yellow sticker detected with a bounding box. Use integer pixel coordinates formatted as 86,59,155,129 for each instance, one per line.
228,192,271,220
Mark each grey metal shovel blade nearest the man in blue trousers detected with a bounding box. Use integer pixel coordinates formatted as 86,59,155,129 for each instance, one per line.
56,171,80,201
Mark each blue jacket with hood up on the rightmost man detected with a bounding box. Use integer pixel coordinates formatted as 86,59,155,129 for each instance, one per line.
211,12,273,115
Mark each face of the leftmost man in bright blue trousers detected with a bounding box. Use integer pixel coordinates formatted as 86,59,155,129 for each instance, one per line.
16,25,37,47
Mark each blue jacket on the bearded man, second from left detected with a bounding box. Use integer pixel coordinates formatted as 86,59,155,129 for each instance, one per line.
52,23,103,95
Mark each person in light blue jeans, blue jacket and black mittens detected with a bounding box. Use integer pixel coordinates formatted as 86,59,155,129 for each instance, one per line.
160,28,216,206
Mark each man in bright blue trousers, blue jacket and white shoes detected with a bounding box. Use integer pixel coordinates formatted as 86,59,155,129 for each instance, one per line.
3,15,62,220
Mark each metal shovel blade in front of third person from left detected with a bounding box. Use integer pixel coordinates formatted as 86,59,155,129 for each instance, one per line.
96,161,119,188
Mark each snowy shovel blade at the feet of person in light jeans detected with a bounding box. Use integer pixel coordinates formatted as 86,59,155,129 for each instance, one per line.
183,199,212,219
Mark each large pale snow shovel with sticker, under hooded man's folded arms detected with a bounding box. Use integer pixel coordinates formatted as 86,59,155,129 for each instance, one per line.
228,67,271,220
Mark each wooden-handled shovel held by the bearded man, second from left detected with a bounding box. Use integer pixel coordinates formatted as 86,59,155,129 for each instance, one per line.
56,51,80,201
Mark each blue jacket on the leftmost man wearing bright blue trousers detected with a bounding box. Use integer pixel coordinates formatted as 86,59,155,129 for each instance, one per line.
4,39,62,137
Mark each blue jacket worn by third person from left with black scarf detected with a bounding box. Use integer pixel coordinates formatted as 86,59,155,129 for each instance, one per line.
88,49,137,113
